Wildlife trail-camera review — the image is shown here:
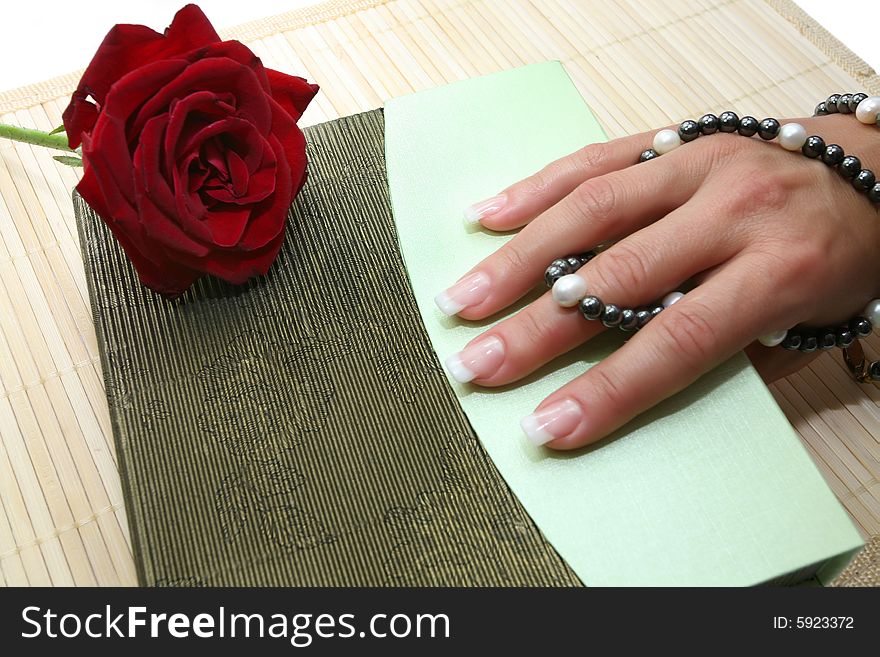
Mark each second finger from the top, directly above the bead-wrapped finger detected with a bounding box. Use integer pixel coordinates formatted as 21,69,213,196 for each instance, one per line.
436,149,707,319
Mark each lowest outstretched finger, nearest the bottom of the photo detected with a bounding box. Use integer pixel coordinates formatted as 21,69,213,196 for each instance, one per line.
522,257,796,449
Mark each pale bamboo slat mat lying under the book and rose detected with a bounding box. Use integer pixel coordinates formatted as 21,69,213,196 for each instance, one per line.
0,0,880,585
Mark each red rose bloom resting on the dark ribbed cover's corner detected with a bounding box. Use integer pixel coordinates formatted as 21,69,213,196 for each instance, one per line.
64,5,318,296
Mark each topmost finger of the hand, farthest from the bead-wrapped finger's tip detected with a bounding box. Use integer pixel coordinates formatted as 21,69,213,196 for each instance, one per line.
464,133,651,231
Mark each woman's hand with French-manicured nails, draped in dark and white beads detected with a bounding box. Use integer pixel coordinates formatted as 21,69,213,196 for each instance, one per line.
438,115,880,449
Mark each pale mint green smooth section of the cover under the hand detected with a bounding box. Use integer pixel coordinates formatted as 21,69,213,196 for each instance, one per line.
386,63,862,585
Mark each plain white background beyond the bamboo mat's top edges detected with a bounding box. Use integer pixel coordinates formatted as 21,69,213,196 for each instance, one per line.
0,0,880,90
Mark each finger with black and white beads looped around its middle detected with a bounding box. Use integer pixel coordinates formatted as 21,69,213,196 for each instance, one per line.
447,204,740,386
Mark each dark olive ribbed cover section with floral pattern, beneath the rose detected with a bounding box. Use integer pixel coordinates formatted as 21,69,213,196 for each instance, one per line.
75,110,580,586
